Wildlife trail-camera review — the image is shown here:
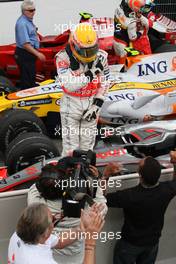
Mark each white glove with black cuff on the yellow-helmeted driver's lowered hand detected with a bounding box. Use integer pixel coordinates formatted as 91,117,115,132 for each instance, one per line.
82,98,104,122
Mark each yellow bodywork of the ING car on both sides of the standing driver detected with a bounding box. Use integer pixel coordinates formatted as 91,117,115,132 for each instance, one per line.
0,80,176,117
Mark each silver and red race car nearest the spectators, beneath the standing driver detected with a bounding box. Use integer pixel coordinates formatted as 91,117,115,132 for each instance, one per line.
0,121,176,192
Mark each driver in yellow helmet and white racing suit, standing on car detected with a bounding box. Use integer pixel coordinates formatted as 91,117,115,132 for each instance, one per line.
56,23,110,156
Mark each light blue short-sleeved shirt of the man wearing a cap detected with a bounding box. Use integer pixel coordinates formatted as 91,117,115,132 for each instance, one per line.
15,15,39,49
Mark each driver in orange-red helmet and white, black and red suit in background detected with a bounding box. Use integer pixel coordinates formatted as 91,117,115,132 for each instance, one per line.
114,0,151,64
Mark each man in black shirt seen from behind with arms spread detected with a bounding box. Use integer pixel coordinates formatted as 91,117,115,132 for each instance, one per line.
104,151,176,264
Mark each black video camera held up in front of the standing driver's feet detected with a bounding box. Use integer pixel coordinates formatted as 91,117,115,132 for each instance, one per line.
58,150,96,218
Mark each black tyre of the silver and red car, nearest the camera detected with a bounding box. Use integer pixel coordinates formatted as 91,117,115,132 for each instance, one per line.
5,133,60,175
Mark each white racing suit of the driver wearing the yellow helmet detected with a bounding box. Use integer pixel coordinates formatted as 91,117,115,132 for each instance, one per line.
56,45,109,156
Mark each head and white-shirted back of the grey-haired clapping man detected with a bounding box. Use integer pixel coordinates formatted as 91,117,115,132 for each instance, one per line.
8,203,59,264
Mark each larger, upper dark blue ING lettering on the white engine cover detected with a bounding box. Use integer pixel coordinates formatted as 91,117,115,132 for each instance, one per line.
137,60,168,77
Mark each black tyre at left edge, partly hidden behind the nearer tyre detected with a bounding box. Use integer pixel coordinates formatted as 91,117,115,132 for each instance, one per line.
0,109,47,151
